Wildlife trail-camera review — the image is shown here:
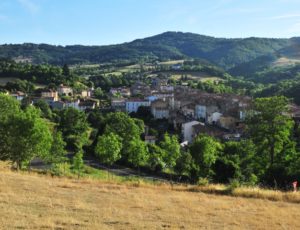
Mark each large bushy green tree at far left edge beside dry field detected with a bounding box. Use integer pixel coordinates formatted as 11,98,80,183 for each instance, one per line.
0,107,52,169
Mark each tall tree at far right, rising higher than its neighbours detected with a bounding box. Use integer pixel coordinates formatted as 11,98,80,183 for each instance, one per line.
246,96,294,166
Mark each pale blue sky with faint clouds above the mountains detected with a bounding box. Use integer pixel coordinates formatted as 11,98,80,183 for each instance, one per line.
0,0,300,45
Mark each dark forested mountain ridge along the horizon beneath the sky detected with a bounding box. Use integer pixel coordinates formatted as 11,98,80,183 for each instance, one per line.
0,32,300,69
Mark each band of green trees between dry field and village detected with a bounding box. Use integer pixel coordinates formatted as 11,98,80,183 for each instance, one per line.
0,95,300,188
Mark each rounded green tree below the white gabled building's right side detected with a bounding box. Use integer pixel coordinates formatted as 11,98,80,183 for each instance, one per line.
190,134,222,180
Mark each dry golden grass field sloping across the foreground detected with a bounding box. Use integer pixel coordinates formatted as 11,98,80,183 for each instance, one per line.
0,166,300,229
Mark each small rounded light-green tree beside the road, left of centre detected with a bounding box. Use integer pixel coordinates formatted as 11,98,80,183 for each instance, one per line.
95,133,122,165
